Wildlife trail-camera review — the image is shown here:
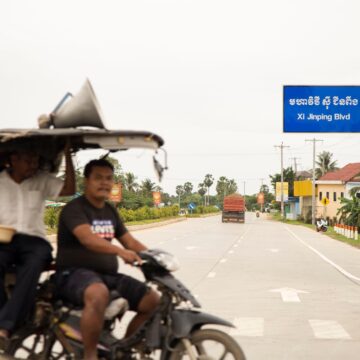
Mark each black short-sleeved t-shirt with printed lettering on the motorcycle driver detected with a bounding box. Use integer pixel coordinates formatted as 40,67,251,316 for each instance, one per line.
56,196,127,274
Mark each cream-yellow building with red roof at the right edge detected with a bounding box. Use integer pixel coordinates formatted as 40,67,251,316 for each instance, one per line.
316,163,360,219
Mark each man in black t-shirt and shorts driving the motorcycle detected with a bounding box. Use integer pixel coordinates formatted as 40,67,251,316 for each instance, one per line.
56,159,159,360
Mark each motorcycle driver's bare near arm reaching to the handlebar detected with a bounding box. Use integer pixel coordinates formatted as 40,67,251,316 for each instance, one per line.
73,224,141,264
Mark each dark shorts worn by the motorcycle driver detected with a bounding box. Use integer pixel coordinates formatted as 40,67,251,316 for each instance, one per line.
57,268,149,311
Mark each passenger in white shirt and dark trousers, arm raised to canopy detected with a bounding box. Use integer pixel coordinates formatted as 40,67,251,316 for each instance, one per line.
0,146,75,348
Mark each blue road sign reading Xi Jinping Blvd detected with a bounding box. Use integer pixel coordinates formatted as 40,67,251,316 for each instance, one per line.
283,86,360,132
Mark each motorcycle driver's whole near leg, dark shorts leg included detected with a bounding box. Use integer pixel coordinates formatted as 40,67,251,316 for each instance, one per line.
58,268,109,360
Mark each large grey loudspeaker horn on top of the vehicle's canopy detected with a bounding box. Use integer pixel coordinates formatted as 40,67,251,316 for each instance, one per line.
51,79,105,129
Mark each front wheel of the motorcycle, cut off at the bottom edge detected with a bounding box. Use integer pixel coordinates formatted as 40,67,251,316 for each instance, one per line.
169,329,246,360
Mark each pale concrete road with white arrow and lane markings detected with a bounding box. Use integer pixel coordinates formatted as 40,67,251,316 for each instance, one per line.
119,214,360,360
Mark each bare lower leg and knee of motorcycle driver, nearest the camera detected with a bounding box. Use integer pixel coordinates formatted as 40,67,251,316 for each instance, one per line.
80,283,109,360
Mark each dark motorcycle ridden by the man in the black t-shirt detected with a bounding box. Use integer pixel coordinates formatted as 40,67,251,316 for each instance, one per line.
0,249,245,360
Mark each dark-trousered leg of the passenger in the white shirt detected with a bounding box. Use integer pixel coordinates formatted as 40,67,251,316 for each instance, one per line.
0,235,52,332
